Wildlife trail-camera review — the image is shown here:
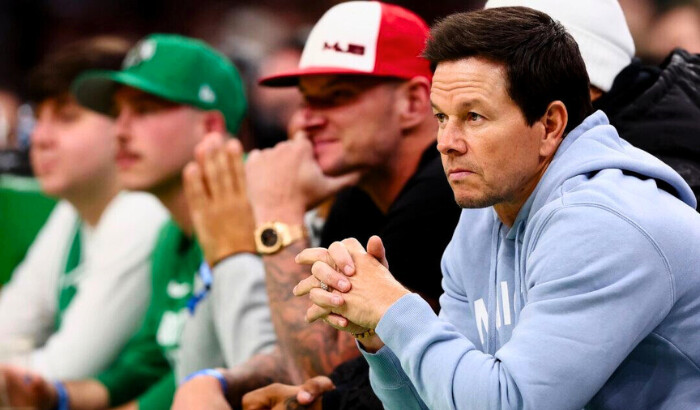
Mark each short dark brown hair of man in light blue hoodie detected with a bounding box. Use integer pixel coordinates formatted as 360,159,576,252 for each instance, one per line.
423,7,593,133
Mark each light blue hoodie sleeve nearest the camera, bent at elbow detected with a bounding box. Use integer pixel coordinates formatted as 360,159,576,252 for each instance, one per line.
370,205,674,409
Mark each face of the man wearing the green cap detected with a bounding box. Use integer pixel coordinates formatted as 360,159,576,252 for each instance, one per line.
114,87,205,194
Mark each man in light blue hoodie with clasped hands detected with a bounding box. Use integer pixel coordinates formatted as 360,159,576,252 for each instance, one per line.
295,7,700,409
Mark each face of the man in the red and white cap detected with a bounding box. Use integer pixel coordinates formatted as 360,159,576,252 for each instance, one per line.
296,75,401,175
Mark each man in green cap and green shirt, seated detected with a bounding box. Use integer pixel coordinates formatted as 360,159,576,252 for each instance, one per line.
2,34,274,410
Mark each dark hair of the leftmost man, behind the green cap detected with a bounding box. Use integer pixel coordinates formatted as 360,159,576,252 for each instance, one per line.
29,36,131,103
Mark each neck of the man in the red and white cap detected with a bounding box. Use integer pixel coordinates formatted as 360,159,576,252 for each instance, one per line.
358,134,434,214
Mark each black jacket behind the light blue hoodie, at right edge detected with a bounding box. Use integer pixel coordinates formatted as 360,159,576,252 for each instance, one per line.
593,49,700,210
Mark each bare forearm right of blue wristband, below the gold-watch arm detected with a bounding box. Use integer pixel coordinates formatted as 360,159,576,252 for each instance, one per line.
221,348,292,408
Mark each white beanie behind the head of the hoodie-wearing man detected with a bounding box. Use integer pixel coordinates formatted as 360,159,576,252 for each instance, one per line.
485,0,634,92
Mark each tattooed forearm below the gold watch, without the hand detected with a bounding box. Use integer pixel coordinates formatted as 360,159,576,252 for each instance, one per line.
263,239,359,384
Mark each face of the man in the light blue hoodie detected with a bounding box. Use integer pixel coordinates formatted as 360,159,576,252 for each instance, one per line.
430,58,544,208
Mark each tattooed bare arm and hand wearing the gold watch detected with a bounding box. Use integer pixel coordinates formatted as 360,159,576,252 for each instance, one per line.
246,136,359,384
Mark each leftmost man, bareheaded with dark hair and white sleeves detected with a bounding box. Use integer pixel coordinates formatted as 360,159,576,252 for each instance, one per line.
0,37,167,380
